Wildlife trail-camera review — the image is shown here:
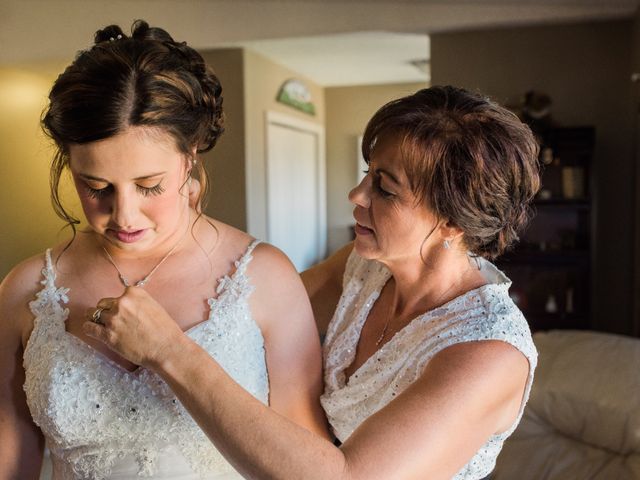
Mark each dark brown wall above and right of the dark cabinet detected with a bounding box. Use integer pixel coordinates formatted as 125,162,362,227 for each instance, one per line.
431,21,635,333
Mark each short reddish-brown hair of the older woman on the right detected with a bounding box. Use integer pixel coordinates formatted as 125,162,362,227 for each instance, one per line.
362,86,540,259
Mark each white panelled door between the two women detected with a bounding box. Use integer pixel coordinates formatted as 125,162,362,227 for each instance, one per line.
267,112,326,271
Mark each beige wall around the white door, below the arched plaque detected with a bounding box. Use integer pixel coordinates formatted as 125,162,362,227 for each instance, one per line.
243,50,325,239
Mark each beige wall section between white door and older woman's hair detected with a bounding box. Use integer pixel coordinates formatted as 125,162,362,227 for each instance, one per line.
325,83,427,253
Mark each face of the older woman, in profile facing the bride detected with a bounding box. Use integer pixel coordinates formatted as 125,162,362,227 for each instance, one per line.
349,133,439,263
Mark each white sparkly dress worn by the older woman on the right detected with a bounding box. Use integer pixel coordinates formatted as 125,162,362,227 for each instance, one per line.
321,252,537,480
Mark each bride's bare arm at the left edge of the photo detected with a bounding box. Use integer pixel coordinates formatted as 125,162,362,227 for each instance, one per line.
0,258,44,480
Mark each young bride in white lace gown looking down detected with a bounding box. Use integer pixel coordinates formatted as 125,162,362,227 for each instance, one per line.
0,21,327,479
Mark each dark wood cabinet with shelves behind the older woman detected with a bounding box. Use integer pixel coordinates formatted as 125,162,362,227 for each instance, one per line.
496,127,595,331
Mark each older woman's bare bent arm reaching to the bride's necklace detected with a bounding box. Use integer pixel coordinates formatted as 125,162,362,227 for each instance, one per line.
85,288,529,480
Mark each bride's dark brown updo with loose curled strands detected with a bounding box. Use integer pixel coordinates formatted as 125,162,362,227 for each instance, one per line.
42,20,224,232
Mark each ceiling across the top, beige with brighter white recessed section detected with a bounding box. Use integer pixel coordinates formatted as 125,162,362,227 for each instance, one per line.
0,0,640,74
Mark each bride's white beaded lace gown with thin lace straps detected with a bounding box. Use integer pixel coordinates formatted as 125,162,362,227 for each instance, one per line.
24,242,269,480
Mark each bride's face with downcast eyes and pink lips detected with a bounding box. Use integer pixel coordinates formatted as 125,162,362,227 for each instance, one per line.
69,127,189,252
